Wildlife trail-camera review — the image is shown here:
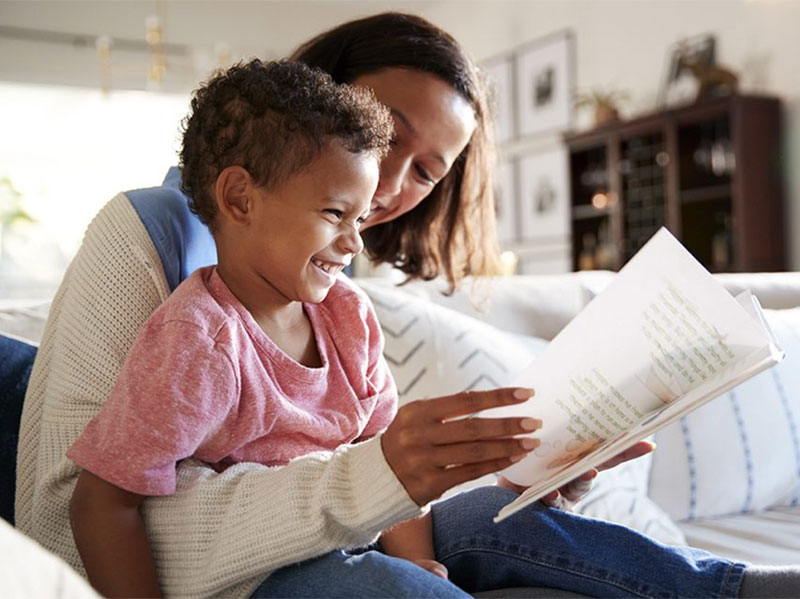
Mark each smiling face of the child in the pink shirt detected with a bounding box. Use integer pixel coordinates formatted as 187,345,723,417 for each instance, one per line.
239,142,378,303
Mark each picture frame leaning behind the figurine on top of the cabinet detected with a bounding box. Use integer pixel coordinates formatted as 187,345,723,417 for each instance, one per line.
658,33,716,108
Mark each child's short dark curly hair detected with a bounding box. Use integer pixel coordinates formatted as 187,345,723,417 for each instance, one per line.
180,60,394,227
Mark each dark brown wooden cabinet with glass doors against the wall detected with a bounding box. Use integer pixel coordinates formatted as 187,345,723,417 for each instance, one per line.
565,95,786,272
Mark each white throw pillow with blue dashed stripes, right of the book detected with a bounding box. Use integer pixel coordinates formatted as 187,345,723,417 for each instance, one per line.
650,308,800,521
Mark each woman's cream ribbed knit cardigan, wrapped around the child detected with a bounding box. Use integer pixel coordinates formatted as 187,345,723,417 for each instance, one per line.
16,194,421,597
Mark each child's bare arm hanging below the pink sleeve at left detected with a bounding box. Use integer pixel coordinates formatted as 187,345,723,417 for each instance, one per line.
69,470,161,597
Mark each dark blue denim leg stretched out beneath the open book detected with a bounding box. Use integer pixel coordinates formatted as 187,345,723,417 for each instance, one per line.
432,487,745,597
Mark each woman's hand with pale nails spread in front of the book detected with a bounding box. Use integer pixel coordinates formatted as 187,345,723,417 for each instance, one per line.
381,388,542,505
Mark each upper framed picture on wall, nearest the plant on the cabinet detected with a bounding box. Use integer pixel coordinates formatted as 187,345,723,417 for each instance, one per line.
515,30,575,137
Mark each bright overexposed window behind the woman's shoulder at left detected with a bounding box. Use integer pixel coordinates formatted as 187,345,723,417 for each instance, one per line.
0,83,189,299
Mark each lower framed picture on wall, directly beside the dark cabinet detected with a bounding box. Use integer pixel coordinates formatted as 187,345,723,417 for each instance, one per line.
517,145,570,242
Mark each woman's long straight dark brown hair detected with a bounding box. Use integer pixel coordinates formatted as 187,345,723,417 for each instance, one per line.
292,13,499,291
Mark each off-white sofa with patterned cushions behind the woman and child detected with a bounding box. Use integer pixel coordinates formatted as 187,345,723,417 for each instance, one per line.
0,271,800,596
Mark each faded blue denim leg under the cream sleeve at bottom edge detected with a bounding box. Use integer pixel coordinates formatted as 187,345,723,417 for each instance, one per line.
251,551,469,599
